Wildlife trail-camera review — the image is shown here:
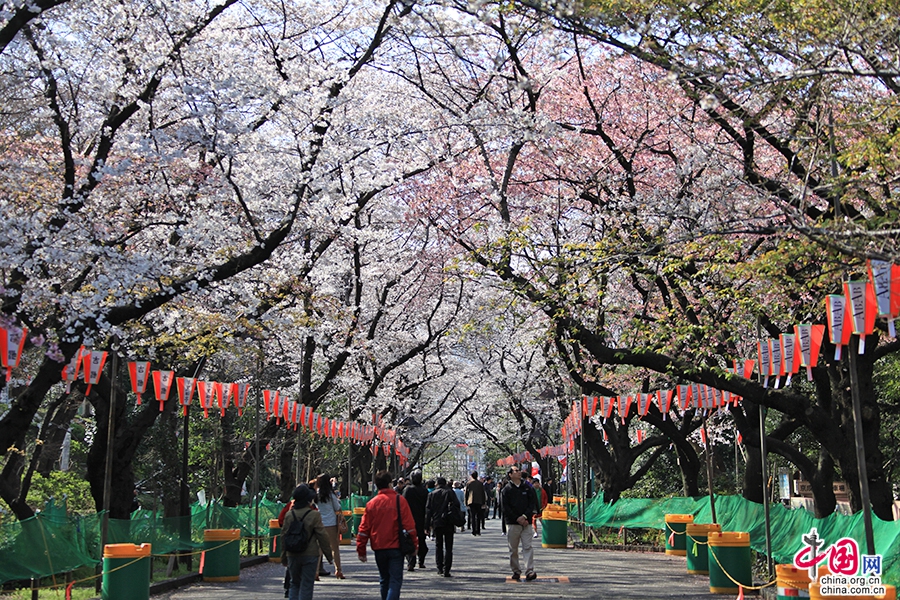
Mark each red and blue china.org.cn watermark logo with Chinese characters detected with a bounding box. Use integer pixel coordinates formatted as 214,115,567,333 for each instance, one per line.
794,527,886,596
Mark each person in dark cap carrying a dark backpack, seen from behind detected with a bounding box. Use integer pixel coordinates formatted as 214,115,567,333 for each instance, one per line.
283,483,332,600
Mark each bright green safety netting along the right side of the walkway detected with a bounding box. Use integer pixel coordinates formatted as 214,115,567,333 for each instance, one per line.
584,496,900,585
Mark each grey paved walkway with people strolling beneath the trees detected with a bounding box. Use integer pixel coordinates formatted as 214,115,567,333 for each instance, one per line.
152,521,735,600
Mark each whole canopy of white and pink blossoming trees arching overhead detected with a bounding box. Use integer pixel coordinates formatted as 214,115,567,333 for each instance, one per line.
0,0,900,518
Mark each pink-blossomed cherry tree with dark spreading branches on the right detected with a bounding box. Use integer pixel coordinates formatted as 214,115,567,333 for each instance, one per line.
398,4,893,515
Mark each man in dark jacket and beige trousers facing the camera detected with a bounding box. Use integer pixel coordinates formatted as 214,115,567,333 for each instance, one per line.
500,466,537,581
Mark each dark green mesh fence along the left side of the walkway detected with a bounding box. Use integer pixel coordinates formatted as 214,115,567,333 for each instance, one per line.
0,500,284,583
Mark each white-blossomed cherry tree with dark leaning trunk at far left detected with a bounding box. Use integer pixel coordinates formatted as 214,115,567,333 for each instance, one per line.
0,1,444,516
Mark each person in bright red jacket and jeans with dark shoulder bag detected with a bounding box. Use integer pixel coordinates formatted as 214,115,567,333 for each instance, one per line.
356,471,419,600
